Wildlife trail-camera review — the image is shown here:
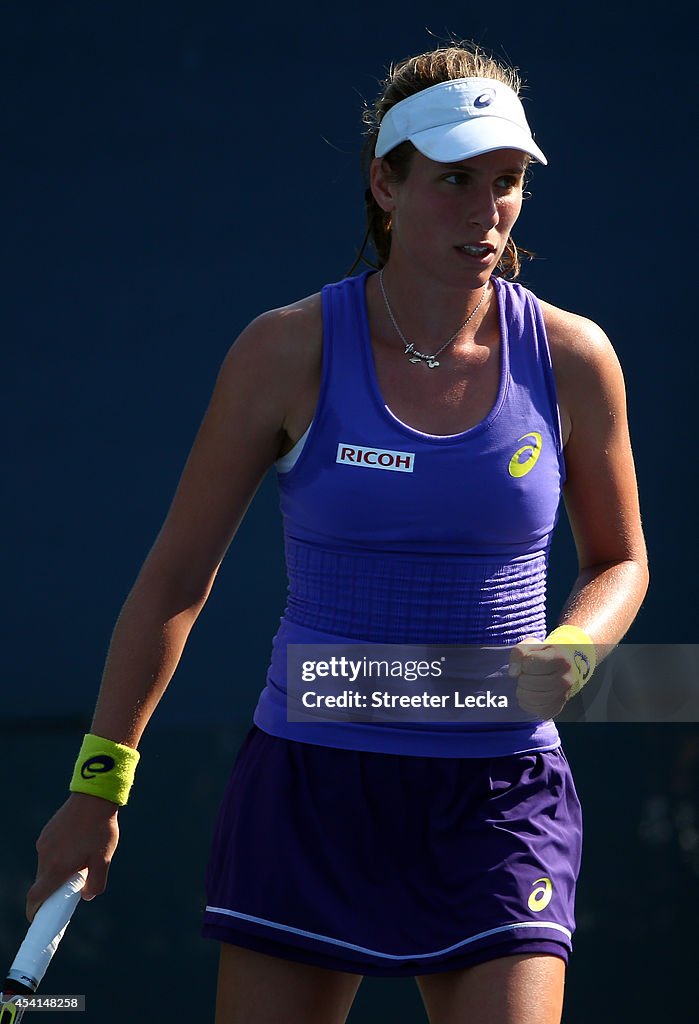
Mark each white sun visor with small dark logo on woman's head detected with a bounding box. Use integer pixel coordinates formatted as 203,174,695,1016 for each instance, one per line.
376,78,549,164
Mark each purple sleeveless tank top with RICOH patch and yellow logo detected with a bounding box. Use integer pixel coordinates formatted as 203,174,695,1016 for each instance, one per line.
255,273,565,757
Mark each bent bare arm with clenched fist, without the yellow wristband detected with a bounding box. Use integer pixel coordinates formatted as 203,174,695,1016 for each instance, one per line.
507,305,649,717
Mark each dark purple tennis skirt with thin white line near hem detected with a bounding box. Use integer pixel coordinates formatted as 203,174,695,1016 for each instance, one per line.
203,726,581,977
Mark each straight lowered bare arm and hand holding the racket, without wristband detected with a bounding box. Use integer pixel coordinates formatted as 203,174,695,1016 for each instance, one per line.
27,297,320,920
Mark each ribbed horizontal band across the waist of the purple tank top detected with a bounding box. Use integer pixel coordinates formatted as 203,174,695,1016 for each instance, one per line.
285,537,548,644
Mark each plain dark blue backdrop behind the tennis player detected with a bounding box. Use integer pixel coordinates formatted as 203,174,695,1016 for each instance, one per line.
0,0,699,1022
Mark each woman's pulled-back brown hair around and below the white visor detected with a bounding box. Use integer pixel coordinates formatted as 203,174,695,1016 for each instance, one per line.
349,42,532,279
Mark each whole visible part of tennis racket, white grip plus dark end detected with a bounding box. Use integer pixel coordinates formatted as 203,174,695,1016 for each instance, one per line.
0,871,85,1024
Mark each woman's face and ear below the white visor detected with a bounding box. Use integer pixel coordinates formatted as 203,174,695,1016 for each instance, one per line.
372,150,527,288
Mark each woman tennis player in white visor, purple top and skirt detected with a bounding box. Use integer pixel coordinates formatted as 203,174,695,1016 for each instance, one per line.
28,44,648,1024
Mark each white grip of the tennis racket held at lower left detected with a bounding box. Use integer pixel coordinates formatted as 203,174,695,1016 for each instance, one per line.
7,871,85,991
